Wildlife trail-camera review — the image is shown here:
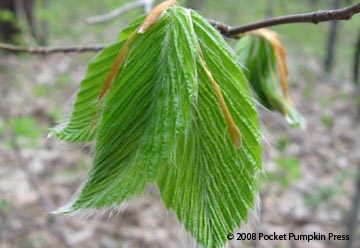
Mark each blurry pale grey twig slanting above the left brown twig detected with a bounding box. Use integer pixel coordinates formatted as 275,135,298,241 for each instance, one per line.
86,0,145,24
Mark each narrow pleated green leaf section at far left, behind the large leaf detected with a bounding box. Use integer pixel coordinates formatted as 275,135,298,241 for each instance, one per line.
51,17,144,142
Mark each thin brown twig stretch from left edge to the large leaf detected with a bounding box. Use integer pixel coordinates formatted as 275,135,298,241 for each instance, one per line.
0,43,107,55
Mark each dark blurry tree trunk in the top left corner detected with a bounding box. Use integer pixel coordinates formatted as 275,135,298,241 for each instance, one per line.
0,0,20,42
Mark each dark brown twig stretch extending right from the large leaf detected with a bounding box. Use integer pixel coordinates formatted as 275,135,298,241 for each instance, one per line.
223,3,360,37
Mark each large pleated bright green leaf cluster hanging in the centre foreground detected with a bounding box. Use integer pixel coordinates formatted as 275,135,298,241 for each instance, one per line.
52,6,261,247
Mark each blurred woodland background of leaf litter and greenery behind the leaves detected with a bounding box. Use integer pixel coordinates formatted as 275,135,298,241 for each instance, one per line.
0,0,360,248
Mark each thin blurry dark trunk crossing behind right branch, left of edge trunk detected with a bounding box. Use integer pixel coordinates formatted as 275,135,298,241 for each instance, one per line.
324,0,342,72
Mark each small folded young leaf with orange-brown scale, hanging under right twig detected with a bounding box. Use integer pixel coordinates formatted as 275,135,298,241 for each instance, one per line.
236,29,305,127
